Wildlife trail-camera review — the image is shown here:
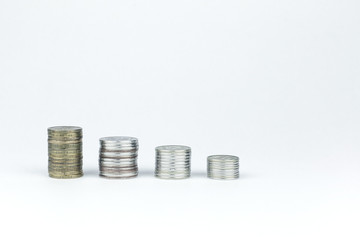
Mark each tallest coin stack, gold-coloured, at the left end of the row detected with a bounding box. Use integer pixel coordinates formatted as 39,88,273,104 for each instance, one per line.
48,126,83,178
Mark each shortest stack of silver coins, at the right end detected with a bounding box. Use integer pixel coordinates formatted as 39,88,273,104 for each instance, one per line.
207,155,239,180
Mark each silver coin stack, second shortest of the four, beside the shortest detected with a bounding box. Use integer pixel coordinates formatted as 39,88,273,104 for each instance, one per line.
155,145,191,179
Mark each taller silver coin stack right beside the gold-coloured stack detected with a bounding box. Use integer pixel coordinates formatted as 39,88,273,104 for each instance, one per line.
99,137,139,178
